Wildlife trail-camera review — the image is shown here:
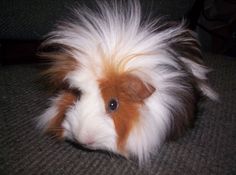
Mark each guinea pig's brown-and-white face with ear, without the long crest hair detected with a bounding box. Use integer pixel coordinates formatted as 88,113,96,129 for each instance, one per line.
41,62,155,157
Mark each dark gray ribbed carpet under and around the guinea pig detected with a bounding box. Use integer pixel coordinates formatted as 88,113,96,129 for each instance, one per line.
0,54,236,175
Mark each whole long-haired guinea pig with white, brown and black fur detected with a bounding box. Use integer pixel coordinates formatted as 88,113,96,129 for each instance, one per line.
39,0,217,162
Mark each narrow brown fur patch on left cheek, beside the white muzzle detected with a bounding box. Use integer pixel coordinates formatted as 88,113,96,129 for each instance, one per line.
46,90,79,139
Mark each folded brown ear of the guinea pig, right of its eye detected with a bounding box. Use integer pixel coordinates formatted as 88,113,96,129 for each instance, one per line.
121,75,156,102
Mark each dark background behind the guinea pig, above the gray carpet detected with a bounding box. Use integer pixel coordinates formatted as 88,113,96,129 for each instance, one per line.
0,0,236,64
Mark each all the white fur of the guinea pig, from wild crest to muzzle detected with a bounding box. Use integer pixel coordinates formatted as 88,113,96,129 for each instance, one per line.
40,0,216,162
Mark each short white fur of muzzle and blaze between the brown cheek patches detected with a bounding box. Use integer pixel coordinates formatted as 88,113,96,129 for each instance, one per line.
62,69,117,151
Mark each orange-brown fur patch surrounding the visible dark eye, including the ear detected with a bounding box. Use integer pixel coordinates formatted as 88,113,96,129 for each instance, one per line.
99,73,155,152
